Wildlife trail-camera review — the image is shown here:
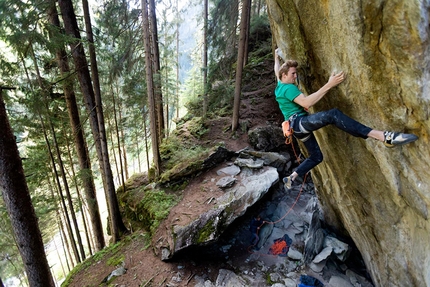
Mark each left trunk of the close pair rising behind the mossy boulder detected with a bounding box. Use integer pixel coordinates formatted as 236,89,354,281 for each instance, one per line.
142,0,161,178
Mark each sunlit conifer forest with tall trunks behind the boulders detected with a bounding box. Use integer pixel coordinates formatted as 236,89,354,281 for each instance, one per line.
0,0,271,286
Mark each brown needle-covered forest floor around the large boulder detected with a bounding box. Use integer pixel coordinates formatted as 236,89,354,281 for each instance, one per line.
63,66,282,287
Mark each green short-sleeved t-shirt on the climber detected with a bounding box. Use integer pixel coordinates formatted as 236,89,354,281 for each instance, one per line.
275,80,306,120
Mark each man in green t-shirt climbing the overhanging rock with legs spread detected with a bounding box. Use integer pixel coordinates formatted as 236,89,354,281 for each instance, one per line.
274,48,418,189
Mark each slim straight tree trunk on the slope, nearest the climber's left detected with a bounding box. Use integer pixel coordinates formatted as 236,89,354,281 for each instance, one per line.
231,0,251,132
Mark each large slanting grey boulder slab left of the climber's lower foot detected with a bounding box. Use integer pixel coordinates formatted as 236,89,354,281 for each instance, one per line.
159,151,282,260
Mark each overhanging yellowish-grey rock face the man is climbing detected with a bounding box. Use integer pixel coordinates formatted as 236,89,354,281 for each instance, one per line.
266,0,430,286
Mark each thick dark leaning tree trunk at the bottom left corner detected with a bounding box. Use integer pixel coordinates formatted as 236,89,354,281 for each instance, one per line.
0,88,55,287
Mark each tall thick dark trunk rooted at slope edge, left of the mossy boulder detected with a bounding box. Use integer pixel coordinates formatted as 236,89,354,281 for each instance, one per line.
58,0,127,242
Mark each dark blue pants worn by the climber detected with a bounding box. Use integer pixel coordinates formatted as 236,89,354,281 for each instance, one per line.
292,109,372,176
